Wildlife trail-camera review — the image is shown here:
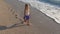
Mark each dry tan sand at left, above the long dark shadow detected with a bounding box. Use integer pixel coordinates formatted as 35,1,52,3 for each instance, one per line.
0,0,17,25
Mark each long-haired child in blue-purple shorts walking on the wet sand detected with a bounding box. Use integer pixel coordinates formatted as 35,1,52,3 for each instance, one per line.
24,4,31,25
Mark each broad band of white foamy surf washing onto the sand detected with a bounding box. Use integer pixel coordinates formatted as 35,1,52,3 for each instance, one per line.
19,0,60,24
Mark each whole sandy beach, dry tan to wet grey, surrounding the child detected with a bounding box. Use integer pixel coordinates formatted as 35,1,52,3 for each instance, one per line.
0,0,60,34
